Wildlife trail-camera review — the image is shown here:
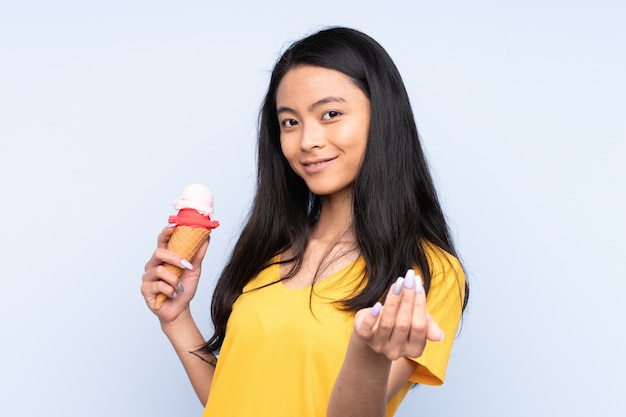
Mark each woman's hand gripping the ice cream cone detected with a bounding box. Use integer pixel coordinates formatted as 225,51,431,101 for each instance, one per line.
141,227,210,324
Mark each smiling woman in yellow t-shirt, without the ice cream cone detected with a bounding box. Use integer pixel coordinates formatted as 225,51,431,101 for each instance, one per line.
142,28,468,417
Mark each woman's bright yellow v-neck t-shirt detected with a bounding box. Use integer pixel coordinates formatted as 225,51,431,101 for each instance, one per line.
203,247,465,417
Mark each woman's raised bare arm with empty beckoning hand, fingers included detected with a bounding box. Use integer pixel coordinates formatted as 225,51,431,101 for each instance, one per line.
327,271,443,417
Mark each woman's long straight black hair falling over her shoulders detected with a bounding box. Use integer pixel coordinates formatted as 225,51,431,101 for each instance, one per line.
201,27,468,353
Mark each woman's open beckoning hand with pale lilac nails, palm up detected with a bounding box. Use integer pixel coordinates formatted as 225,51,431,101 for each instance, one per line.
354,269,444,360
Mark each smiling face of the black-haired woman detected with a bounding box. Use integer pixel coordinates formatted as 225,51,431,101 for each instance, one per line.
276,65,370,196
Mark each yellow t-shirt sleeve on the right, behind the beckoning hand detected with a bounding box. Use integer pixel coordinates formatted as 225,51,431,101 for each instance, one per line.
409,245,465,385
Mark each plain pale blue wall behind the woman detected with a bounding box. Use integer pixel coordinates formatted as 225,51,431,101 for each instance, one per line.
0,0,626,417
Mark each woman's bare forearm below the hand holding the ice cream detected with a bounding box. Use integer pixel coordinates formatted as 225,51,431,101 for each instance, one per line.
161,310,216,406
